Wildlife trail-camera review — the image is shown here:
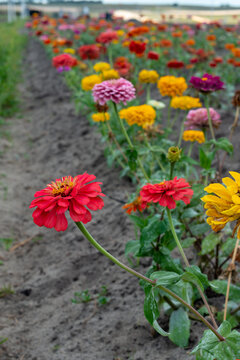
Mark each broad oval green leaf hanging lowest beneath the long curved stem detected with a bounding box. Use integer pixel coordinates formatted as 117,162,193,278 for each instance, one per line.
169,308,190,347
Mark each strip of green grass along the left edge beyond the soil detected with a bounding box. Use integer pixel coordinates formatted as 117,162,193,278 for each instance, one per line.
0,21,27,117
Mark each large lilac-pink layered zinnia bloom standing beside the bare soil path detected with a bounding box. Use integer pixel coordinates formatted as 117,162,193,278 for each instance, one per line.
93,78,136,105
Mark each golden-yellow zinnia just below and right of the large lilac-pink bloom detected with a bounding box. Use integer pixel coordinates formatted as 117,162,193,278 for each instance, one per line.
119,104,156,129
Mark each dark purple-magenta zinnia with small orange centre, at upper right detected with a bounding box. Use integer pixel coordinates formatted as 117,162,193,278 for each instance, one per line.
190,74,224,94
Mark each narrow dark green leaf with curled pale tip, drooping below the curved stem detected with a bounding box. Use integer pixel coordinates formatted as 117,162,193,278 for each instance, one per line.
144,287,169,336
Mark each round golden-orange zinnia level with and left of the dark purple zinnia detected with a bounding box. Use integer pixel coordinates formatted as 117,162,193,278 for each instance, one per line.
157,76,188,97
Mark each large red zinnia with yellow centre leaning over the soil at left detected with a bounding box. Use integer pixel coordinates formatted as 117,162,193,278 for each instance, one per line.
29,172,105,231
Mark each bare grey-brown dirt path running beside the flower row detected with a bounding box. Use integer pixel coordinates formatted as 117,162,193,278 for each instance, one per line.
0,40,199,360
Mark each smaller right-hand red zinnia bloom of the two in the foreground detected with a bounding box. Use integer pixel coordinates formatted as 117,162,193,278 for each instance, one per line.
140,177,193,209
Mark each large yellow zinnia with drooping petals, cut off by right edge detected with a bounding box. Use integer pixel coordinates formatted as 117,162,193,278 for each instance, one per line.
201,171,240,238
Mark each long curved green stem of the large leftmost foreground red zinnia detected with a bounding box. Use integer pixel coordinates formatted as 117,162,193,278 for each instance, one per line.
76,222,225,341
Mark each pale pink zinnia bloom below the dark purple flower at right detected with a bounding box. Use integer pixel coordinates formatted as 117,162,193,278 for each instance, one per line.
184,108,221,130
